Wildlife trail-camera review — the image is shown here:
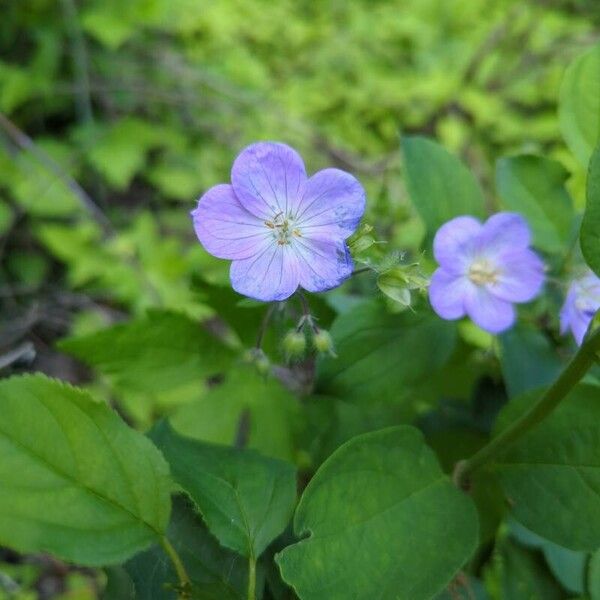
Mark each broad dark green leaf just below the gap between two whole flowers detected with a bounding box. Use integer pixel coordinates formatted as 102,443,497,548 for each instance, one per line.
317,302,457,403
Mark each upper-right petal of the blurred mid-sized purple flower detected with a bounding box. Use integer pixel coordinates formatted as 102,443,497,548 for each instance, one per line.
478,212,531,256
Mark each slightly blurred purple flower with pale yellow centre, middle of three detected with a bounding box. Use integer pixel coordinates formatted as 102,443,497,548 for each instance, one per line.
429,213,544,333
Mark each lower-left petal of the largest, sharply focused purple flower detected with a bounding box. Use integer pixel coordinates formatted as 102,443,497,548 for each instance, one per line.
229,241,298,302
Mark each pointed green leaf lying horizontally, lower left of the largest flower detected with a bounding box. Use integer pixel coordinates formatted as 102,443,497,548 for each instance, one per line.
58,310,233,393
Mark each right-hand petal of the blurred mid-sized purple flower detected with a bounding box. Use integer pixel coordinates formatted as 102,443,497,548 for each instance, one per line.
488,249,544,302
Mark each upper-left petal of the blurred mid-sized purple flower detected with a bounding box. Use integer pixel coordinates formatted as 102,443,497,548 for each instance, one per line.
433,216,482,273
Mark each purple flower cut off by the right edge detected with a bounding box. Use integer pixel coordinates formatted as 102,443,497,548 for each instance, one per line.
560,271,600,345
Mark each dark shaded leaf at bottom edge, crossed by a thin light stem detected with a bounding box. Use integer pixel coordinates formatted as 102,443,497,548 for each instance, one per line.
125,496,250,600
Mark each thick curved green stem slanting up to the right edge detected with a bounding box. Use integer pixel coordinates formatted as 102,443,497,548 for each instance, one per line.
453,328,600,491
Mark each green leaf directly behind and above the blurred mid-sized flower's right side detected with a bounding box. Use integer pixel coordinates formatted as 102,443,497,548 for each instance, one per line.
496,155,575,252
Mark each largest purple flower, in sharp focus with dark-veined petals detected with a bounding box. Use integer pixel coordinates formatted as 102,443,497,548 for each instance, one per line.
192,142,365,301
